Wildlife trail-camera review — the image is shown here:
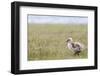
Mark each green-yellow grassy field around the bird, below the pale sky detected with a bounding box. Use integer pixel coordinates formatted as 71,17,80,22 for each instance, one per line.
28,24,88,60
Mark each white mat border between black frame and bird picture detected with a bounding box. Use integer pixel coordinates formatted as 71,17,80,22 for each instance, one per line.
20,6,94,70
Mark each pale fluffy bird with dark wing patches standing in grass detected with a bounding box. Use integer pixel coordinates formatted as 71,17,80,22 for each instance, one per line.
66,38,84,56
